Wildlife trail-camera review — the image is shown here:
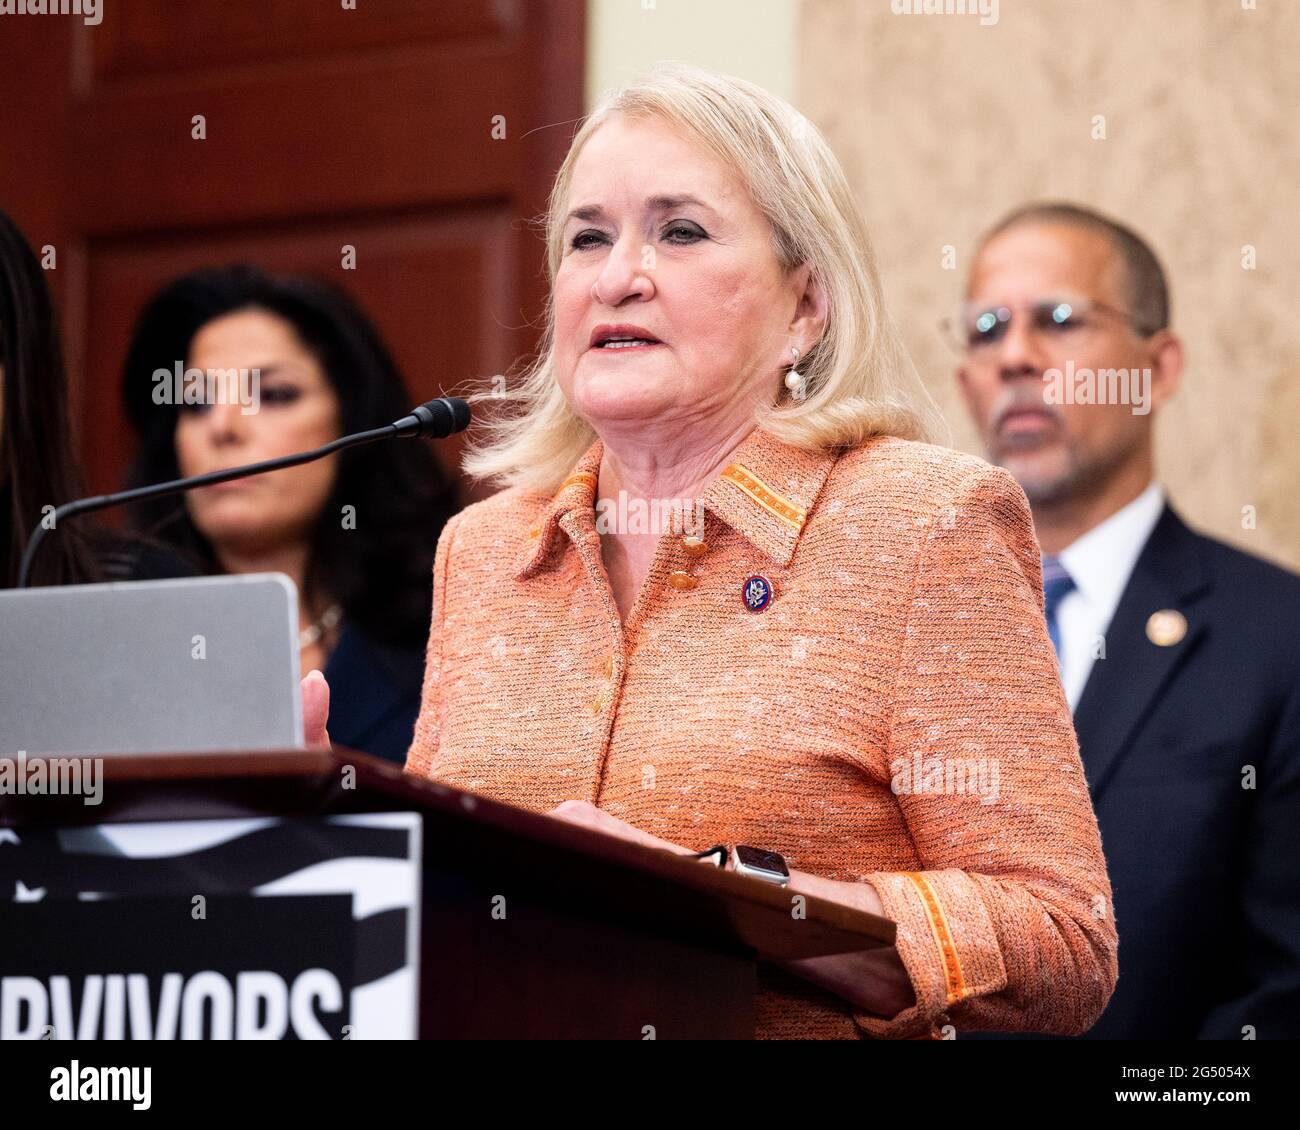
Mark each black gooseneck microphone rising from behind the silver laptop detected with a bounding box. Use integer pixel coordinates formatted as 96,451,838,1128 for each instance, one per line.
18,397,471,589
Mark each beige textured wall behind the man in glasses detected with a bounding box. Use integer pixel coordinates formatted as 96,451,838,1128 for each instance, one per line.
794,0,1300,568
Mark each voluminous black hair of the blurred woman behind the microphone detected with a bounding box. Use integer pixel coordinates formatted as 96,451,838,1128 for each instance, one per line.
122,264,456,645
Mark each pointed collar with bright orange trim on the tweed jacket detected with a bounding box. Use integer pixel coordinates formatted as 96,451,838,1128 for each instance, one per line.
516,428,839,580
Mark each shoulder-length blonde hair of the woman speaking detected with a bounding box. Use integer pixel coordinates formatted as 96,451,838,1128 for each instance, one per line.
463,64,937,492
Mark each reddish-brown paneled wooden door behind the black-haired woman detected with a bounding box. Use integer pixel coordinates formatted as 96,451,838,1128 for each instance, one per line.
0,0,585,498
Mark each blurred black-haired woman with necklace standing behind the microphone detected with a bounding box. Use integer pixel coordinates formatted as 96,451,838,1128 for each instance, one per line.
124,260,456,762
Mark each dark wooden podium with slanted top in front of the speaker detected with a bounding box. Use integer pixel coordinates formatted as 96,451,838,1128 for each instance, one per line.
0,750,894,1039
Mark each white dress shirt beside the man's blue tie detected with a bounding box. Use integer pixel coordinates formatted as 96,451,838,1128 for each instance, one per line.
1057,481,1165,711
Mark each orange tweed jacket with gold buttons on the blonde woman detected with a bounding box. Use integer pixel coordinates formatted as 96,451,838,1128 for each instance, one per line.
407,429,1117,1038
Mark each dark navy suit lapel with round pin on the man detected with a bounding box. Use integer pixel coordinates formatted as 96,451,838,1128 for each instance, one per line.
1074,505,1210,805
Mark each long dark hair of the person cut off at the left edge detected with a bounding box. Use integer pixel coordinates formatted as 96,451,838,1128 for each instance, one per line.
0,211,101,588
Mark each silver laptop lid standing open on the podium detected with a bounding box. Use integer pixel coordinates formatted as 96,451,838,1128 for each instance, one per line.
0,573,303,757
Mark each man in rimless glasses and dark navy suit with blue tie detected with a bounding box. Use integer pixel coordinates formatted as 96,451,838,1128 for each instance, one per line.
952,204,1300,1039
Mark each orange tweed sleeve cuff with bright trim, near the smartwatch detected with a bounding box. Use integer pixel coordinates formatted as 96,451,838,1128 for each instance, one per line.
854,870,1006,1039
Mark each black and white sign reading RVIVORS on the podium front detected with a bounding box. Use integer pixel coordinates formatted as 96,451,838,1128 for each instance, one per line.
0,813,420,1040
